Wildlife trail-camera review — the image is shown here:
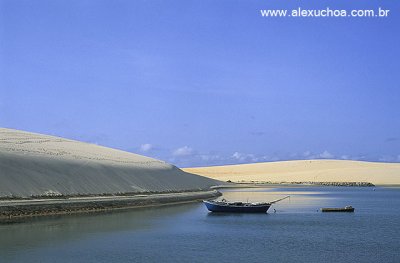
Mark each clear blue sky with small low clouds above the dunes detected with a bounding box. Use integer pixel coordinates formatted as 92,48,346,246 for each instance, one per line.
0,0,400,167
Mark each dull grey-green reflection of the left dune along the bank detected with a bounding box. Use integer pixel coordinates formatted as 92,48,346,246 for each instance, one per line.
0,202,197,252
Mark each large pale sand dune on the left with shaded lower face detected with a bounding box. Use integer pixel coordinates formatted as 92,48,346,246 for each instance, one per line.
0,128,218,197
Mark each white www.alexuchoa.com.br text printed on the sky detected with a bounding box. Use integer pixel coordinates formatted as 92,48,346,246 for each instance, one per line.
260,7,390,18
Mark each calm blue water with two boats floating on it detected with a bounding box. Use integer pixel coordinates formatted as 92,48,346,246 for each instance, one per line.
0,187,400,263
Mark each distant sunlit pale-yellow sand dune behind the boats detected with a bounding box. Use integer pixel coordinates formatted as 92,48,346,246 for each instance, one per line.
183,160,400,185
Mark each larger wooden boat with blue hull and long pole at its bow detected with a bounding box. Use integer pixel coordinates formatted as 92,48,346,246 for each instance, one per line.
203,196,289,213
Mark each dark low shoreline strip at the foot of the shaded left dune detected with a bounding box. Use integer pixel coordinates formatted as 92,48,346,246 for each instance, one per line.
0,190,222,224
